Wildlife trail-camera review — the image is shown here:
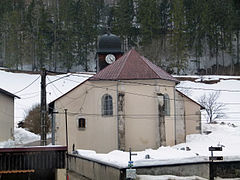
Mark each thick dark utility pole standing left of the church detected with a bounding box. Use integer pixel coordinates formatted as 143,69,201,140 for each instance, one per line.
40,68,47,146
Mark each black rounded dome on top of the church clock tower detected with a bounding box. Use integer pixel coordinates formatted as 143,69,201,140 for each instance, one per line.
97,34,122,53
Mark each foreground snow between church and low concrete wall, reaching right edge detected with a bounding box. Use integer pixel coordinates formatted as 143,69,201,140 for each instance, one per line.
77,121,240,168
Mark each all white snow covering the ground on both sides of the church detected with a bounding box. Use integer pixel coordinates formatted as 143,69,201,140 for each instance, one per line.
0,70,240,173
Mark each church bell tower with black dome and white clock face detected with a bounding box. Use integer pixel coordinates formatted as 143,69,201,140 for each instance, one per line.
97,33,123,72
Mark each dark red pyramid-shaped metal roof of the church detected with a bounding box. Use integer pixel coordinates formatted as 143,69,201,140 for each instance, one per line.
90,49,178,82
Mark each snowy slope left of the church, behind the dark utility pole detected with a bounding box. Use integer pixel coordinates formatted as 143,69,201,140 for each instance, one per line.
0,70,91,147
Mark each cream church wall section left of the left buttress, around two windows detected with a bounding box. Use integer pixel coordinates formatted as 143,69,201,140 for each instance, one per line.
55,81,117,152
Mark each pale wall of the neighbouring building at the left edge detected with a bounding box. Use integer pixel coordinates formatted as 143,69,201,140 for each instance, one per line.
0,93,14,141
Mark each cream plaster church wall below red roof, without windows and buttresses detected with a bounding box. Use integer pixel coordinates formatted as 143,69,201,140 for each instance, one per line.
55,80,175,152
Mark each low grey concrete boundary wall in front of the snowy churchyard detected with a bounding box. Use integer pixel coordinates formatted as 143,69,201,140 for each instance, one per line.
66,155,240,180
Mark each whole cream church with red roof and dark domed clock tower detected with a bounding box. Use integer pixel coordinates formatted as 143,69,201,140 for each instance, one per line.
49,34,202,153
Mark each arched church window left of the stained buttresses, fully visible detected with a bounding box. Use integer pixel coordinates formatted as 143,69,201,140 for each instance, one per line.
102,94,113,116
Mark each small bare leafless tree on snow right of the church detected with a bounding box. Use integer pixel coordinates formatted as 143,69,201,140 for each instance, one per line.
199,91,225,123
